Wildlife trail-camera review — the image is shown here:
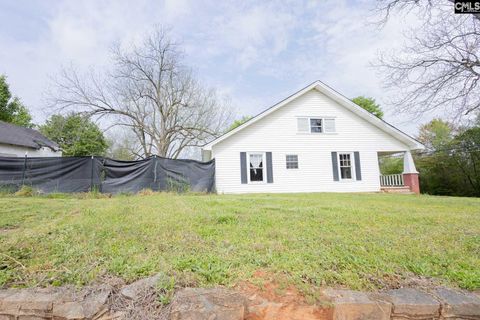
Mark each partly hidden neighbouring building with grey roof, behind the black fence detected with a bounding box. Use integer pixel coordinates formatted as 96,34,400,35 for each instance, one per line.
0,121,62,157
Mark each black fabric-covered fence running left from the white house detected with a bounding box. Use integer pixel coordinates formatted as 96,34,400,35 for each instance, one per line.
0,156,215,193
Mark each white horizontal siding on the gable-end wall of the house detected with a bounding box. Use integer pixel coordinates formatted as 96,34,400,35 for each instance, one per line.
212,90,409,193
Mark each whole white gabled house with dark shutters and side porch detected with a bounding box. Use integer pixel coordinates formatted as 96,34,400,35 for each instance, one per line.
202,81,424,193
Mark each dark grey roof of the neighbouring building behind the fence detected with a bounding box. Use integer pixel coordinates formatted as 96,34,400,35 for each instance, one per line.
0,121,60,151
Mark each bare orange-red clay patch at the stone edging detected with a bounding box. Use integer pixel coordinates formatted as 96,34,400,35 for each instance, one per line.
236,271,333,320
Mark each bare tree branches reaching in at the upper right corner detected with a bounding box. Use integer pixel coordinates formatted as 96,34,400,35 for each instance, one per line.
377,0,480,119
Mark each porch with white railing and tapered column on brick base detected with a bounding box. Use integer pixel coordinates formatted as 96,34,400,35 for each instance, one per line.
379,151,420,194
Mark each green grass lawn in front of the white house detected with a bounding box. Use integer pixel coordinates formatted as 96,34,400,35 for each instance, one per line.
0,193,480,296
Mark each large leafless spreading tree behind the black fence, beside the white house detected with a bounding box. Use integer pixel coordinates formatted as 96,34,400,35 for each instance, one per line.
49,30,231,158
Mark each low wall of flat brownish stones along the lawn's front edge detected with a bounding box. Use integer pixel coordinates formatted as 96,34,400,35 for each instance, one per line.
0,277,480,320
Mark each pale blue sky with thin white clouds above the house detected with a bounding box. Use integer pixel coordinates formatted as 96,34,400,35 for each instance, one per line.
0,0,428,134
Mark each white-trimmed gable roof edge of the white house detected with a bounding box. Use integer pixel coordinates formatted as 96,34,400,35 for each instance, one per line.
203,80,425,150
